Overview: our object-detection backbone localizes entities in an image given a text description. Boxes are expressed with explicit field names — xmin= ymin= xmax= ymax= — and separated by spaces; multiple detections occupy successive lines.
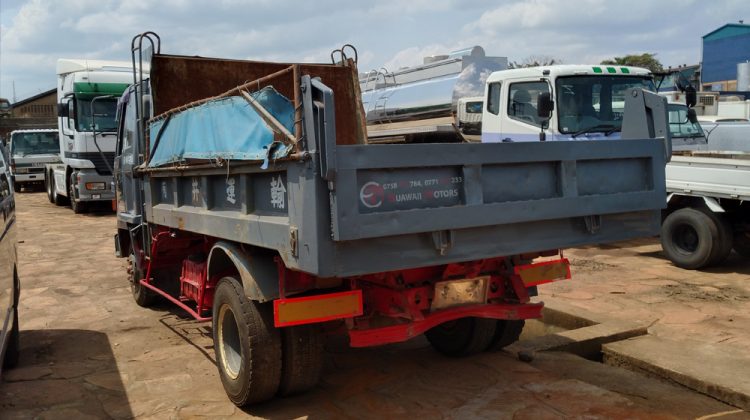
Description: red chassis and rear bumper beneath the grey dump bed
xmin=139 ymin=228 xmax=570 ymax=347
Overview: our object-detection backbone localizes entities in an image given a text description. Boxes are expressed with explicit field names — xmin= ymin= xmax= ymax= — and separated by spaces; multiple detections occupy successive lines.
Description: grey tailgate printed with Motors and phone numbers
xmin=331 ymin=139 xmax=666 ymax=242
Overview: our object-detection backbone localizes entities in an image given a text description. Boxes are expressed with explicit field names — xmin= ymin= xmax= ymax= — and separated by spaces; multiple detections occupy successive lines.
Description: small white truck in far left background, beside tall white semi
xmin=9 ymin=129 xmax=60 ymax=192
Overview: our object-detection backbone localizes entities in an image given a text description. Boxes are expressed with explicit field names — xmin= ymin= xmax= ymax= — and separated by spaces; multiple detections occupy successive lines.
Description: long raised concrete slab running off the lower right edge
xmin=602 ymin=336 xmax=750 ymax=410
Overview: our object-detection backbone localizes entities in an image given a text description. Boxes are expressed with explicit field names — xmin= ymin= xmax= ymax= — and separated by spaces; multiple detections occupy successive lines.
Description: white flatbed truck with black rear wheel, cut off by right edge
xmin=661 ymin=100 xmax=750 ymax=269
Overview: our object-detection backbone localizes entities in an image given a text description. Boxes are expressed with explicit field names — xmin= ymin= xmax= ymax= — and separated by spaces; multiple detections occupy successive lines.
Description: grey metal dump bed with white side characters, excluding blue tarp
xmin=143 ymin=56 xmax=667 ymax=277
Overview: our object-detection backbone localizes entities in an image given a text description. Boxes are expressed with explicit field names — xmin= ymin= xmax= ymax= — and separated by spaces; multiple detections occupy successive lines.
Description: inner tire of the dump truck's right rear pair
xmin=424 ymin=318 xmax=497 ymax=357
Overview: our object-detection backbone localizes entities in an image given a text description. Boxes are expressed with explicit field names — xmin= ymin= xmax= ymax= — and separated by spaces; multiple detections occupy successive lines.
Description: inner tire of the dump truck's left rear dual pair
xmin=278 ymin=325 xmax=323 ymax=396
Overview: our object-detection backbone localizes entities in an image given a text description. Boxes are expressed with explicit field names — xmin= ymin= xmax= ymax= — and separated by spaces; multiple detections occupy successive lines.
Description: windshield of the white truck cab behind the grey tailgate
xmin=555 ymin=76 xmax=655 ymax=134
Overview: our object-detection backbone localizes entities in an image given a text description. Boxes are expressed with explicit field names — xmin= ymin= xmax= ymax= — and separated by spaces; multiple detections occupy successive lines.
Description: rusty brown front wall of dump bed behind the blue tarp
xmin=151 ymin=54 xmax=366 ymax=145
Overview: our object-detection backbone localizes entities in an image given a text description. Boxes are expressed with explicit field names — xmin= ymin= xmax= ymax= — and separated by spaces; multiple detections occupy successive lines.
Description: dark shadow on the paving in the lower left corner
xmin=0 ymin=330 xmax=133 ymax=419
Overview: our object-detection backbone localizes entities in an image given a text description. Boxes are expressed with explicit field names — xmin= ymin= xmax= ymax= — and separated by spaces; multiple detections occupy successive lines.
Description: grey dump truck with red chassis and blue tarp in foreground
xmin=114 ymin=33 xmax=670 ymax=406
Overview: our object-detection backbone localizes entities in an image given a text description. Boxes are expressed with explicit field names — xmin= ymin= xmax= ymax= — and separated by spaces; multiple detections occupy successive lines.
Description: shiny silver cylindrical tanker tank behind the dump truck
xmin=359 ymin=46 xmax=508 ymax=124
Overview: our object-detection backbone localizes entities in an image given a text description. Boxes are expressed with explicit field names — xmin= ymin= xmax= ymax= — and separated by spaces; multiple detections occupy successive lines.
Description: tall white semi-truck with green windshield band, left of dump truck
xmin=44 ymin=59 xmax=133 ymax=213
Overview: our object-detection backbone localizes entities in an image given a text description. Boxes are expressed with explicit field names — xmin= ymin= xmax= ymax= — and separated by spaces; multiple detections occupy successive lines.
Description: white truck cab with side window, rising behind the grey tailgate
xmin=482 ymin=65 xmax=655 ymax=143
